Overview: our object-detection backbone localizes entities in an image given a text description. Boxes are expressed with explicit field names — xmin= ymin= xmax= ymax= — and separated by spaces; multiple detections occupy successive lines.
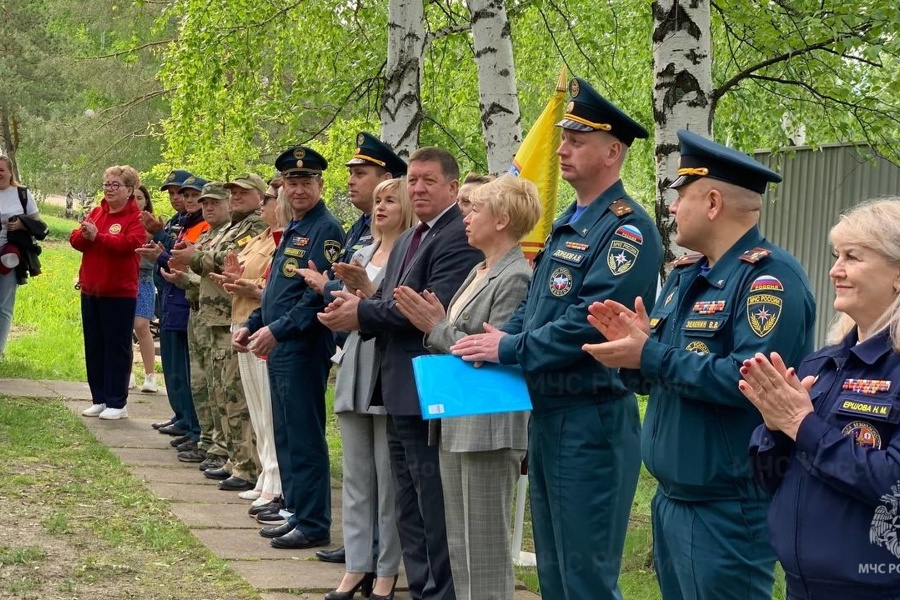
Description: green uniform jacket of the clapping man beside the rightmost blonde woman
xmin=622 ymin=227 xmax=816 ymax=501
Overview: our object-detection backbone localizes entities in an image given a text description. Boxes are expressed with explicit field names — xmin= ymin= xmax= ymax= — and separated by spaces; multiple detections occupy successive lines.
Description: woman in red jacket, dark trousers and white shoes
xmin=69 ymin=165 xmax=146 ymax=419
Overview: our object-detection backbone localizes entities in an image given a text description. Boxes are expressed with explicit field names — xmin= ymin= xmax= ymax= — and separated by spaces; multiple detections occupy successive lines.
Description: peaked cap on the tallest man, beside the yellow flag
xmin=556 ymin=77 xmax=649 ymax=146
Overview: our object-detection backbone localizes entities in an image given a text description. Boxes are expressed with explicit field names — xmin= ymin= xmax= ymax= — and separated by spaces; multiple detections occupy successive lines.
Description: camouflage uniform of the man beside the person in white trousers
xmin=190 ymin=211 xmax=266 ymax=482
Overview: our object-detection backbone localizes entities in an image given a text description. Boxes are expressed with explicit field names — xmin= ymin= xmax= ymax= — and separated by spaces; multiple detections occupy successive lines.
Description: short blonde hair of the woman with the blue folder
xmin=469 ymin=173 xmax=541 ymax=240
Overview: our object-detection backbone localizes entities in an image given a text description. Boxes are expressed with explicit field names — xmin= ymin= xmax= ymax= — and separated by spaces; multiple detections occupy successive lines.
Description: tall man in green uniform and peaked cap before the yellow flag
xmin=452 ymin=79 xmax=662 ymax=600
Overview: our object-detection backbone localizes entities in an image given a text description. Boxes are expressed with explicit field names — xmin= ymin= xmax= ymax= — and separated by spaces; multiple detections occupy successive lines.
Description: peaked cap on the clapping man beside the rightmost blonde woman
xmin=669 ymin=129 xmax=781 ymax=194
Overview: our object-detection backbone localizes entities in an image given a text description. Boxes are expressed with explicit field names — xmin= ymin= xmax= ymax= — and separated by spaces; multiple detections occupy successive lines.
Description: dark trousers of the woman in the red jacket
xmin=81 ymin=294 xmax=137 ymax=408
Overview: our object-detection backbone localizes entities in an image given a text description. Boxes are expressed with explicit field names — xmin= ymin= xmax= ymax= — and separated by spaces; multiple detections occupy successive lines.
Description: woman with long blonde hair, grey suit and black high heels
xmin=325 ymin=179 xmax=414 ymax=600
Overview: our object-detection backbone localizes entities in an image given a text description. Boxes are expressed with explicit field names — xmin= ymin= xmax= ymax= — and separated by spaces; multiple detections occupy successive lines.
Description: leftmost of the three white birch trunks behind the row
xmin=381 ymin=0 xmax=426 ymax=158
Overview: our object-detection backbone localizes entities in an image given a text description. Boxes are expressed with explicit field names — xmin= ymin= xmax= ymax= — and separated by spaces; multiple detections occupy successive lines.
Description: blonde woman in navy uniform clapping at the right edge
xmin=739 ymin=198 xmax=900 ymax=600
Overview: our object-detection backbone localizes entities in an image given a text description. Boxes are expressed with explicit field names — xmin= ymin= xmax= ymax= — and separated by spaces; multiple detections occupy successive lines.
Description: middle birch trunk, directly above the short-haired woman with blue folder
xmin=468 ymin=0 xmax=522 ymax=175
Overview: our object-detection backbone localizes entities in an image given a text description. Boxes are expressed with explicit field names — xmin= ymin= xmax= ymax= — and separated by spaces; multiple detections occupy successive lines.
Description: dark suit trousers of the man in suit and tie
xmin=388 ymin=415 xmax=456 ymax=600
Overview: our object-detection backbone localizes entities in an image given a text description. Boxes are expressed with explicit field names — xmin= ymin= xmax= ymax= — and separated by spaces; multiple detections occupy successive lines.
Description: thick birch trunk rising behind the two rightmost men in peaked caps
xmin=653 ymin=0 xmax=712 ymax=260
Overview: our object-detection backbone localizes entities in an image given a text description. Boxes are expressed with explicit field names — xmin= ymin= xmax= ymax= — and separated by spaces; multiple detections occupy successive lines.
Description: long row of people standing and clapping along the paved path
xmin=0 ymin=74 xmax=884 ymax=600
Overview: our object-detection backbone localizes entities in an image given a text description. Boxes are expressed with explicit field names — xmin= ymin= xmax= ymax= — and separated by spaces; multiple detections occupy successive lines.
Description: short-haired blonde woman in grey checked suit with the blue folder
xmin=394 ymin=175 xmax=541 ymax=600
